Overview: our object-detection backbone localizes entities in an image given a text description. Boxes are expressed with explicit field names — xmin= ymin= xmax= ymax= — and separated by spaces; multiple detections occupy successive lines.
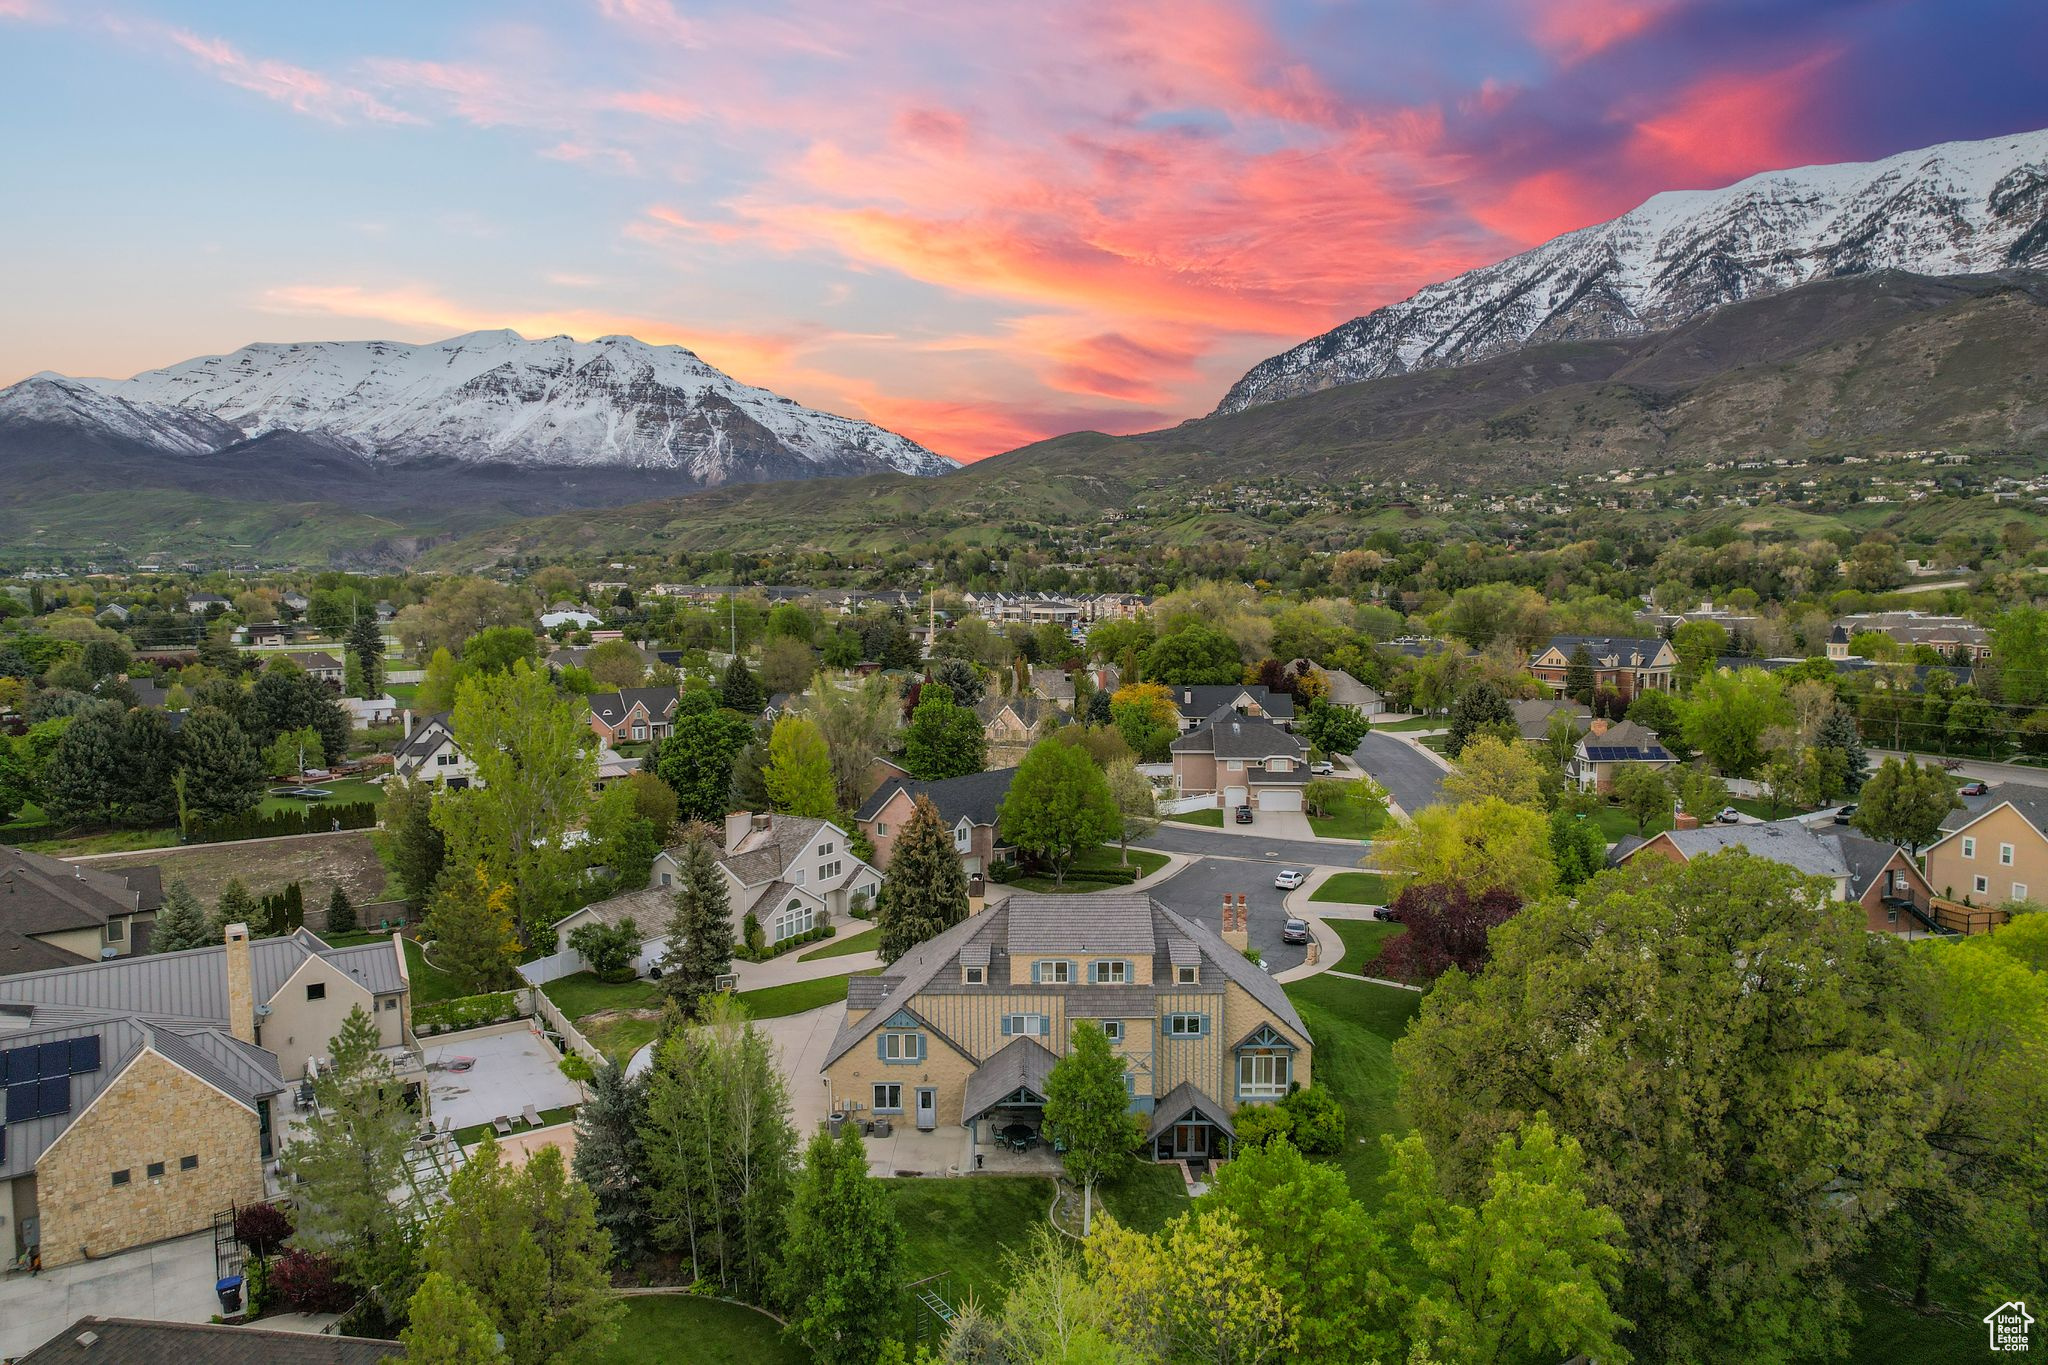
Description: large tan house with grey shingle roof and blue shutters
xmin=823 ymin=892 xmax=1313 ymax=1169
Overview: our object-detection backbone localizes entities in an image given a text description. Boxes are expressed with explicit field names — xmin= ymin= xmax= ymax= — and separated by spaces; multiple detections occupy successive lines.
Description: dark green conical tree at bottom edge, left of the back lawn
xmin=774 ymin=1124 xmax=903 ymax=1365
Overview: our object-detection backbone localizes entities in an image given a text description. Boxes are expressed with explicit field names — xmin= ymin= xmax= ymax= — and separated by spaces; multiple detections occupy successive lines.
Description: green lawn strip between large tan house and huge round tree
xmin=1286 ymin=974 xmax=1421 ymax=1205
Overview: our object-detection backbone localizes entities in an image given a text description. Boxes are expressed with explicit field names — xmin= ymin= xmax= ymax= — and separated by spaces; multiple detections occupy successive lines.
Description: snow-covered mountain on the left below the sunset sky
xmin=0 ymin=332 xmax=954 ymax=485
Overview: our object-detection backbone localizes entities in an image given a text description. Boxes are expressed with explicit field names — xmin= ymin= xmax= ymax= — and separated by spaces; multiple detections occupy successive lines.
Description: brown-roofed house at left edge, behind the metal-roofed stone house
xmin=0 ymin=845 xmax=164 ymax=976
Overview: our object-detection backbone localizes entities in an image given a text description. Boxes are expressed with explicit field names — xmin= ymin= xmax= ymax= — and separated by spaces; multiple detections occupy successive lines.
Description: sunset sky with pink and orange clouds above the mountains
xmin=0 ymin=0 xmax=2048 ymax=458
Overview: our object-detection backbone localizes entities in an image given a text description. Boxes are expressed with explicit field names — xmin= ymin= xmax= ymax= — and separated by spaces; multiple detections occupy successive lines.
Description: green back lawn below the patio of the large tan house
xmin=883 ymin=1175 xmax=1053 ymax=1308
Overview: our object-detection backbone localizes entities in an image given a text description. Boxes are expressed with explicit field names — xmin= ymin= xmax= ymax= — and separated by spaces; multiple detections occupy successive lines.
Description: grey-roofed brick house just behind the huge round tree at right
xmin=1616 ymin=821 xmax=1948 ymax=937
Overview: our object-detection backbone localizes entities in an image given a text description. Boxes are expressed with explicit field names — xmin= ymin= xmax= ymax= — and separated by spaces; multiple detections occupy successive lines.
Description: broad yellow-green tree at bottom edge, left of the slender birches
xmin=422 ymin=1134 xmax=625 ymax=1365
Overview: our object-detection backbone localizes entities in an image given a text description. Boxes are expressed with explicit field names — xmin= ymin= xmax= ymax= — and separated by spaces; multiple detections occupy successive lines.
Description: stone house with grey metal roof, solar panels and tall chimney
xmin=0 ymin=925 xmax=426 ymax=1267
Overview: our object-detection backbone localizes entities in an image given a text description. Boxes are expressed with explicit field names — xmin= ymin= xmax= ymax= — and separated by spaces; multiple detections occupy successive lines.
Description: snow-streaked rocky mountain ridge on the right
xmin=1217 ymin=131 xmax=2048 ymax=413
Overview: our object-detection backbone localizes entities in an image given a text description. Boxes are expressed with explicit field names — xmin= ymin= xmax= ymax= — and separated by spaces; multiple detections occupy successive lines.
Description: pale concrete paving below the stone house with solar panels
xmin=0 ymin=1232 xmax=221 ymax=1361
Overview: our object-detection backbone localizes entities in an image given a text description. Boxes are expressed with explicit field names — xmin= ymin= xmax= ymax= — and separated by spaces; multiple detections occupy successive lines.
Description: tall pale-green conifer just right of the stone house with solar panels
xmin=283 ymin=1005 xmax=418 ymax=1316
